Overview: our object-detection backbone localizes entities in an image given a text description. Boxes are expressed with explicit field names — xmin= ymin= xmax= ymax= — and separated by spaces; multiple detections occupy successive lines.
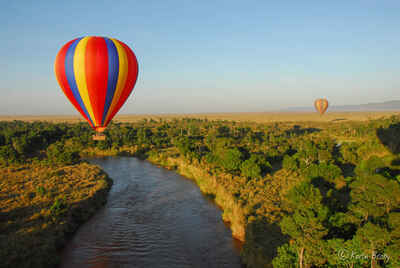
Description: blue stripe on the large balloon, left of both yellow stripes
xmin=64 ymin=37 xmax=94 ymax=126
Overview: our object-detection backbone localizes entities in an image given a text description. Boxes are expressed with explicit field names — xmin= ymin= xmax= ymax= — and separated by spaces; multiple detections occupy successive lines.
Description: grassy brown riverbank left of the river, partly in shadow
xmin=0 ymin=162 xmax=112 ymax=268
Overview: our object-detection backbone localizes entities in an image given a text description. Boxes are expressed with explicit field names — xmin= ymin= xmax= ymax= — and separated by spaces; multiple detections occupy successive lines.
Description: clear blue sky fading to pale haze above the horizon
xmin=0 ymin=0 xmax=400 ymax=114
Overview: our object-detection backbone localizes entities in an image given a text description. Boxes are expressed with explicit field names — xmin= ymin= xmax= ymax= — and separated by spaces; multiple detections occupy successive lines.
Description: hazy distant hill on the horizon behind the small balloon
xmin=285 ymin=100 xmax=400 ymax=112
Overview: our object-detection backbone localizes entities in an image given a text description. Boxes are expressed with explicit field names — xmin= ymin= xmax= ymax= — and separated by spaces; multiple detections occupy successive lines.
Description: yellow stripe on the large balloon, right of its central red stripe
xmin=104 ymin=38 xmax=128 ymax=122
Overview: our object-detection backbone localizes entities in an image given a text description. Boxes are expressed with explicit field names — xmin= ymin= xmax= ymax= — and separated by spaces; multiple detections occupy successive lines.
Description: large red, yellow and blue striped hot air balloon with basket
xmin=54 ymin=36 xmax=138 ymax=139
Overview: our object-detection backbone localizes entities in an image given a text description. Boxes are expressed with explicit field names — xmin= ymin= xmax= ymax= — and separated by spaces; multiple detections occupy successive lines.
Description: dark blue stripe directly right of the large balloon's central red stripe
xmin=101 ymin=37 xmax=119 ymax=125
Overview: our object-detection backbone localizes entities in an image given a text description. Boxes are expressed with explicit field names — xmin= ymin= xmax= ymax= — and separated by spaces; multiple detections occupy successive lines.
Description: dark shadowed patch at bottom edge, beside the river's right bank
xmin=241 ymin=218 xmax=289 ymax=267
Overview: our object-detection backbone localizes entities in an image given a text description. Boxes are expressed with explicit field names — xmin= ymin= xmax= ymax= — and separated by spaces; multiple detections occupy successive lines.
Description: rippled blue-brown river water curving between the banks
xmin=60 ymin=157 xmax=241 ymax=268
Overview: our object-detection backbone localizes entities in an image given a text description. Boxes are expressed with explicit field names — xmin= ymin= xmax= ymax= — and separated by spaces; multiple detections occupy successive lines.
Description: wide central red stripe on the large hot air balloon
xmin=85 ymin=37 xmax=108 ymax=126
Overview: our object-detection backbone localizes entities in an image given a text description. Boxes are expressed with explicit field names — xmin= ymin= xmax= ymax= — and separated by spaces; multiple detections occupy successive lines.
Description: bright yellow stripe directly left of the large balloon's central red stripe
xmin=74 ymin=37 xmax=100 ymax=127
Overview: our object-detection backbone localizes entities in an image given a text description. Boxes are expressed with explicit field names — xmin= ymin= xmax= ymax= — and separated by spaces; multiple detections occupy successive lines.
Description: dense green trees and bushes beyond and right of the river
xmin=0 ymin=116 xmax=400 ymax=267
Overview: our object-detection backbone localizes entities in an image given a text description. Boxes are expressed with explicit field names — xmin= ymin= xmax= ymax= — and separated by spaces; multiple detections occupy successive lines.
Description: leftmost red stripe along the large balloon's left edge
xmin=54 ymin=38 xmax=94 ymax=128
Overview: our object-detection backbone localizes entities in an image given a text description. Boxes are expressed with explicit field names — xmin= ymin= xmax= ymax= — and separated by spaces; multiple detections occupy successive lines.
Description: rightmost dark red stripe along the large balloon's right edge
xmin=104 ymin=40 xmax=138 ymax=126
